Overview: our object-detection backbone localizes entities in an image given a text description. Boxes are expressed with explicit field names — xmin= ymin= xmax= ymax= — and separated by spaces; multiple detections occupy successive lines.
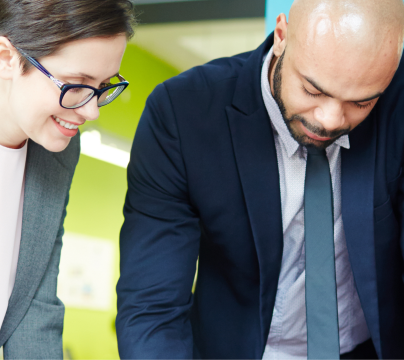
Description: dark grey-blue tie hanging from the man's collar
xmin=304 ymin=147 xmax=339 ymax=359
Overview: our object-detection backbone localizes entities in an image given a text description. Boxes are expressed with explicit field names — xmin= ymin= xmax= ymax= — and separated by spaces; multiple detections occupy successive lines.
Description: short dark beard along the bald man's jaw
xmin=274 ymin=49 xmax=350 ymax=149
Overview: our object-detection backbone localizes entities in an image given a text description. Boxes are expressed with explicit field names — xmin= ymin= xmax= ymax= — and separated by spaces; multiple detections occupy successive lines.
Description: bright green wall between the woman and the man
xmin=63 ymin=44 xmax=178 ymax=359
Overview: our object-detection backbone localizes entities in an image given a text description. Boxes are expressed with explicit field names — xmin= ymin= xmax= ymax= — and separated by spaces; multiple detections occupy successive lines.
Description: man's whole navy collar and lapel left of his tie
xmin=226 ymin=32 xmax=283 ymax=358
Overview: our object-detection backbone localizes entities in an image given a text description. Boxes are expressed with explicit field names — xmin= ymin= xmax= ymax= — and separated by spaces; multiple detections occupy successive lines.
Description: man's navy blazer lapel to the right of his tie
xmin=341 ymin=116 xmax=381 ymax=357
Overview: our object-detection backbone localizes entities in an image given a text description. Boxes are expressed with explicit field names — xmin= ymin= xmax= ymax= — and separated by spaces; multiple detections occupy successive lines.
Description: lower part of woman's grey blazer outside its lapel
xmin=4 ymin=196 xmax=69 ymax=359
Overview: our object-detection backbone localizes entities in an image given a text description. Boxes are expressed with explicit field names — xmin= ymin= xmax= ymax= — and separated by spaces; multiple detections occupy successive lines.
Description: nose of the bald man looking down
xmin=314 ymin=99 xmax=345 ymax=131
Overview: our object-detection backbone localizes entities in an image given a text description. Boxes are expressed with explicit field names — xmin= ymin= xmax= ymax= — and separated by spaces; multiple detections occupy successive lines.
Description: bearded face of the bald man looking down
xmin=272 ymin=37 xmax=397 ymax=148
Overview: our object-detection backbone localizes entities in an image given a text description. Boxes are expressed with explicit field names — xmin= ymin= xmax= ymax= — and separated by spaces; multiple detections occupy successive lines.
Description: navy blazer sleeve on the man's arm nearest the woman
xmin=116 ymin=84 xmax=200 ymax=359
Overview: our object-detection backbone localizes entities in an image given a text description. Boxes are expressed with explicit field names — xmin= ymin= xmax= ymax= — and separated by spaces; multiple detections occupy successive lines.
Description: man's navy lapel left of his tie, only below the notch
xmin=227 ymin=108 xmax=283 ymax=352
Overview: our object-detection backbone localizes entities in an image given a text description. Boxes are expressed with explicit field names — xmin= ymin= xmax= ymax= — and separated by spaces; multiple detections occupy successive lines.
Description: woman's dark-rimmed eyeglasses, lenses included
xmin=15 ymin=47 xmax=129 ymax=109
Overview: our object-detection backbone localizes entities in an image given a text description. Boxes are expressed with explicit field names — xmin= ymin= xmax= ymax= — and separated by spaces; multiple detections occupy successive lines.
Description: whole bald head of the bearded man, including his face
xmin=269 ymin=0 xmax=404 ymax=148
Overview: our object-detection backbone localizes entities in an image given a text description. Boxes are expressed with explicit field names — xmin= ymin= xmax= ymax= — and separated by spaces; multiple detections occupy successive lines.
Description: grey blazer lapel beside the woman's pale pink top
xmin=0 ymin=141 xmax=71 ymax=346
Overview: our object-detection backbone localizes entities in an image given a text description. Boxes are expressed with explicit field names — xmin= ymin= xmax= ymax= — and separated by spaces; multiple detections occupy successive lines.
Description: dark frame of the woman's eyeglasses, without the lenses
xmin=14 ymin=46 xmax=129 ymax=109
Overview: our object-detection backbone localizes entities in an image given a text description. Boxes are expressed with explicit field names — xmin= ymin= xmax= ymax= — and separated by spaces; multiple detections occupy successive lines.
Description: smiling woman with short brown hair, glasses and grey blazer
xmin=0 ymin=0 xmax=134 ymax=359
